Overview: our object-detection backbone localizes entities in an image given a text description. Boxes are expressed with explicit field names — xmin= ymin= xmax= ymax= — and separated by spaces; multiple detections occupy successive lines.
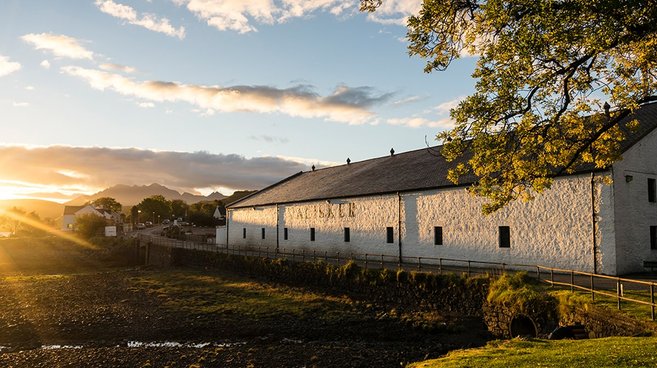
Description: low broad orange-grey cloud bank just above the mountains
xmin=0 ymin=146 xmax=309 ymax=193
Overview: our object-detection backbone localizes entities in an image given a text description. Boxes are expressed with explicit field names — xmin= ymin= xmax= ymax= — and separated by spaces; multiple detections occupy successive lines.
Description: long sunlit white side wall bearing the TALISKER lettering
xmin=228 ymin=174 xmax=616 ymax=274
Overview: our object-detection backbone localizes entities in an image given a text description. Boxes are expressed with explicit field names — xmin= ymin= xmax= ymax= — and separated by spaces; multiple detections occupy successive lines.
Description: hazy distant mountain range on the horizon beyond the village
xmin=66 ymin=183 xmax=226 ymax=206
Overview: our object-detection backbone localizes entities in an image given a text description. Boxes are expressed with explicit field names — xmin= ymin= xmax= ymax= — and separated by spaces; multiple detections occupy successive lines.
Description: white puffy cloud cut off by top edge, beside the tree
xmin=174 ymin=0 xmax=421 ymax=33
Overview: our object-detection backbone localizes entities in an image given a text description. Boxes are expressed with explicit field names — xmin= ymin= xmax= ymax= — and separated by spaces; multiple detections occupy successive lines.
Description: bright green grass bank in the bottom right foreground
xmin=410 ymin=337 xmax=657 ymax=368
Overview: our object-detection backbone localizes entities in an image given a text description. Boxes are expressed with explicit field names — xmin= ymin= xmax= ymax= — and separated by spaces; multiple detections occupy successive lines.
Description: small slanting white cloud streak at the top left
xmin=96 ymin=0 xmax=185 ymax=40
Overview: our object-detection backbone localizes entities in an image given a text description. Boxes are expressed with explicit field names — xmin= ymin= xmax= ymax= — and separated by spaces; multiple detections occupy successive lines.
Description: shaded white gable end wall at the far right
xmin=613 ymin=126 xmax=657 ymax=273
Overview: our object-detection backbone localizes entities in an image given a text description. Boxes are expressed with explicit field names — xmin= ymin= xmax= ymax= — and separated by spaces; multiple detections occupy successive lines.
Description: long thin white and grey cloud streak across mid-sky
xmin=61 ymin=66 xmax=390 ymax=124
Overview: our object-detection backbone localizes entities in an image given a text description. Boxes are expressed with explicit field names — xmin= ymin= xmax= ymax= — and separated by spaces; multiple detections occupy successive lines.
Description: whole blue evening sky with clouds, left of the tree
xmin=0 ymin=0 xmax=476 ymax=202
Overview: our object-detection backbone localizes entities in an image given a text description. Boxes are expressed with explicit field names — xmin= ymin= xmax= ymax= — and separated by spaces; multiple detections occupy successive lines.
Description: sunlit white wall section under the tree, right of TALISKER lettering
xmin=404 ymin=175 xmax=611 ymax=271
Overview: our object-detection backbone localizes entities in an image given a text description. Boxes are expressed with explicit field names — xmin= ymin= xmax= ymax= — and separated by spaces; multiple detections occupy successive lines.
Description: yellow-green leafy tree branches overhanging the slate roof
xmin=361 ymin=0 xmax=657 ymax=213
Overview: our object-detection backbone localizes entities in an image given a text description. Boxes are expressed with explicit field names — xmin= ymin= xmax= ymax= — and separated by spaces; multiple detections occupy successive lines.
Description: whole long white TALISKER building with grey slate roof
xmin=222 ymin=104 xmax=657 ymax=275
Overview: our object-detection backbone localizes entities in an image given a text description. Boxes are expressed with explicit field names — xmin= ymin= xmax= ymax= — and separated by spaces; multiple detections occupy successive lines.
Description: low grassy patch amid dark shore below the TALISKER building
xmin=131 ymin=270 xmax=356 ymax=320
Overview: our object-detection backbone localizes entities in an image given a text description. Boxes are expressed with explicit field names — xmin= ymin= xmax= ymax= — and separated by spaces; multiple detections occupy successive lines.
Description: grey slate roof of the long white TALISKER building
xmin=228 ymin=103 xmax=657 ymax=208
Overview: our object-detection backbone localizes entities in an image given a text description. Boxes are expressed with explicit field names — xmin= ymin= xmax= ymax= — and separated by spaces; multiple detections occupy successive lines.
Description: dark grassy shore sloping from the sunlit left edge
xmin=0 ymin=239 xmax=487 ymax=368
